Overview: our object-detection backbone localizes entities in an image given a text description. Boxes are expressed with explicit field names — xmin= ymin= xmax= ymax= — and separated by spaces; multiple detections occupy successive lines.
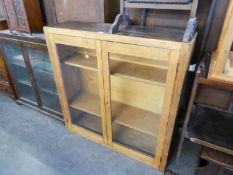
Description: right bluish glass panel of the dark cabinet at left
xmin=26 ymin=48 xmax=61 ymax=113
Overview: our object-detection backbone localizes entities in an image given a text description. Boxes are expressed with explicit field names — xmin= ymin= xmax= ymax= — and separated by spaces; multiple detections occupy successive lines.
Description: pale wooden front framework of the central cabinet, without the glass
xmin=44 ymin=22 xmax=196 ymax=171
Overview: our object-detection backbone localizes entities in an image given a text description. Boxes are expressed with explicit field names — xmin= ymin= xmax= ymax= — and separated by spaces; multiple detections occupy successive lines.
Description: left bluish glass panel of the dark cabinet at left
xmin=3 ymin=43 xmax=36 ymax=103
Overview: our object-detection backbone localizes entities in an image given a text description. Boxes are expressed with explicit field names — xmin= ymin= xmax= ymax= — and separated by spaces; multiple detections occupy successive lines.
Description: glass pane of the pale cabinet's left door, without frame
xmin=57 ymin=44 xmax=103 ymax=135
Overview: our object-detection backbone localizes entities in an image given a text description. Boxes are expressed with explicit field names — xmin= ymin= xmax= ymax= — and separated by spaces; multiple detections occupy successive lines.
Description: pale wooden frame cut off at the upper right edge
xmin=208 ymin=1 xmax=233 ymax=84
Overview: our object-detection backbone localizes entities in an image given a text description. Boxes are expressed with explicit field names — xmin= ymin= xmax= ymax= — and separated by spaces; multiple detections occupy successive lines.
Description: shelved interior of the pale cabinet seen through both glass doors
xmin=57 ymin=44 xmax=169 ymax=157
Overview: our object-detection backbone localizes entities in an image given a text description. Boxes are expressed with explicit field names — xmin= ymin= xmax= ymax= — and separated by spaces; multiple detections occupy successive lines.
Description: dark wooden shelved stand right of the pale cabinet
xmin=177 ymin=55 xmax=233 ymax=158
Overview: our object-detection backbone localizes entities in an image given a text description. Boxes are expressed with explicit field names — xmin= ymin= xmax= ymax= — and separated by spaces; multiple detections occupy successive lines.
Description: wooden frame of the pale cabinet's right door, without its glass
xmin=102 ymin=41 xmax=180 ymax=168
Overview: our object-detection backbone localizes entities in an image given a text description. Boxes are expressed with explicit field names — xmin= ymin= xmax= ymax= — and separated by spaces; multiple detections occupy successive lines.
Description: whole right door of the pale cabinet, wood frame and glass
xmin=102 ymin=42 xmax=178 ymax=164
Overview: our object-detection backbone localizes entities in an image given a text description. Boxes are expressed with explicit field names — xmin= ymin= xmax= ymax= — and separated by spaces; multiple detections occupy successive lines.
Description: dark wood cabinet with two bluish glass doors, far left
xmin=0 ymin=32 xmax=62 ymax=120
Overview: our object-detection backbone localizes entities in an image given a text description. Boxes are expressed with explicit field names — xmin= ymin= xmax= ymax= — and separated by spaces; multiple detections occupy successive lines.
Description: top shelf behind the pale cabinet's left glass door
xmin=64 ymin=53 xmax=98 ymax=71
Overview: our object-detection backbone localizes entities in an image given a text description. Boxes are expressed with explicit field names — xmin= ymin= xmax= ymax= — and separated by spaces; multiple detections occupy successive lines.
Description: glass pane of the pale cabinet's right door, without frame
xmin=109 ymin=53 xmax=168 ymax=157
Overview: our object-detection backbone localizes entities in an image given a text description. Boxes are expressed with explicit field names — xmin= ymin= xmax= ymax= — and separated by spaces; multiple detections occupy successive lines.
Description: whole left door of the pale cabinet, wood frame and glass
xmin=52 ymin=35 xmax=106 ymax=142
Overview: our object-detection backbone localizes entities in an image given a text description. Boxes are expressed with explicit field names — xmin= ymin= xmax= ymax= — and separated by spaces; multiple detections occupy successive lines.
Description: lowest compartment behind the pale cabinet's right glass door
xmin=113 ymin=124 xmax=156 ymax=156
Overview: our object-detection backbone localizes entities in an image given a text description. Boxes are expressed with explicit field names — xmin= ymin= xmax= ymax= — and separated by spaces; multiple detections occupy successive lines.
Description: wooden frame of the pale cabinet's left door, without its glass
xmin=45 ymin=30 xmax=107 ymax=144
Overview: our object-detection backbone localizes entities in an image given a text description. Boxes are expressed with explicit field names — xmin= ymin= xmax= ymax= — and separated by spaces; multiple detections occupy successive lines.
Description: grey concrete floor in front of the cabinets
xmin=0 ymin=93 xmax=199 ymax=175
